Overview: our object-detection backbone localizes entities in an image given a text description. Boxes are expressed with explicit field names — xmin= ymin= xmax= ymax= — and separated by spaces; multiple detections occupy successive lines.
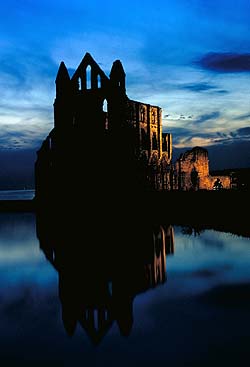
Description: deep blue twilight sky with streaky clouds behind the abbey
xmin=0 ymin=0 xmax=250 ymax=168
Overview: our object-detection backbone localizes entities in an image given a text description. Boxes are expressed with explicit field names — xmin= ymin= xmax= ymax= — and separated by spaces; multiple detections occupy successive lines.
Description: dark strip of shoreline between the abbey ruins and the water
xmin=0 ymin=191 xmax=250 ymax=237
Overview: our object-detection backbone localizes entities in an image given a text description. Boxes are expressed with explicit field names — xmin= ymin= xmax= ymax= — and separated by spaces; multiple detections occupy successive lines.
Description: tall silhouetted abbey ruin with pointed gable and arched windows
xmin=35 ymin=53 xmax=172 ymax=203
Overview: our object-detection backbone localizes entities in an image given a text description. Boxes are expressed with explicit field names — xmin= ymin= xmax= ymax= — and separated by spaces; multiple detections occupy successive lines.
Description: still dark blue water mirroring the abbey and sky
xmin=0 ymin=213 xmax=250 ymax=367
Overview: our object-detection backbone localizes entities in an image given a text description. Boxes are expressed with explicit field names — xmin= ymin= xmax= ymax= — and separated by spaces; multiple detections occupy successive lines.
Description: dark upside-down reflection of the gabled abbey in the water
xmin=37 ymin=218 xmax=174 ymax=344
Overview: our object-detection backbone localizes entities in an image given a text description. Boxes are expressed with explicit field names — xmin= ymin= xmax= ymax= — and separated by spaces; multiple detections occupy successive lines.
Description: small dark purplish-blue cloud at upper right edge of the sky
xmin=198 ymin=52 xmax=250 ymax=73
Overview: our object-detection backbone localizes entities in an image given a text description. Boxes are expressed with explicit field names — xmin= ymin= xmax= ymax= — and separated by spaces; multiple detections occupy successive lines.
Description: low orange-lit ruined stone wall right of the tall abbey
xmin=175 ymin=147 xmax=231 ymax=191
